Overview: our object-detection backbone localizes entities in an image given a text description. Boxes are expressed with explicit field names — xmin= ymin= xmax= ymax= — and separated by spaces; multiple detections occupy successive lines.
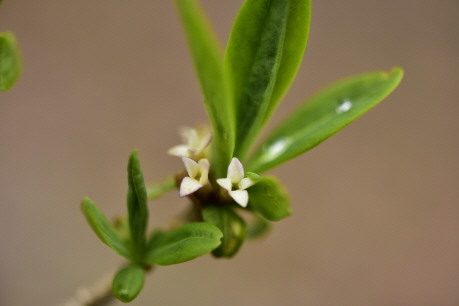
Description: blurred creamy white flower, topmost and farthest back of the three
xmin=167 ymin=127 xmax=212 ymax=158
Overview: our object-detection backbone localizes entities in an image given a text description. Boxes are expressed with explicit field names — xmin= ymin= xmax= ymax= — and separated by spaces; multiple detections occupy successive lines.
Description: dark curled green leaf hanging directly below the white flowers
xmin=202 ymin=206 xmax=247 ymax=257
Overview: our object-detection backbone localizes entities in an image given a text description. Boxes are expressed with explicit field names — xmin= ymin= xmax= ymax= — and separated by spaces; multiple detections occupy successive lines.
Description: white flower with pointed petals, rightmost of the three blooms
xmin=217 ymin=157 xmax=256 ymax=207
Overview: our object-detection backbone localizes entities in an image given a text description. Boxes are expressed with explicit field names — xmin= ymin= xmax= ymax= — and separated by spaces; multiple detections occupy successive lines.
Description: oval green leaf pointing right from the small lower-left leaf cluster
xmin=147 ymin=222 xmax=223 ymax=266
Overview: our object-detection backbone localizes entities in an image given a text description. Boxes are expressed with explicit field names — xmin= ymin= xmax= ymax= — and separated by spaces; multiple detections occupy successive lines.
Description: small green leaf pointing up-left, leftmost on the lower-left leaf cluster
xmin=81 ymin=198 xmax=130 ymax=259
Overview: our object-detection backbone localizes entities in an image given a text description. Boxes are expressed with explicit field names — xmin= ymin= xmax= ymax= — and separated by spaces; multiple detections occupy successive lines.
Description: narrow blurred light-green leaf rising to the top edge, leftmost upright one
xmin=176 ymin=0 xmax=235 ymax=177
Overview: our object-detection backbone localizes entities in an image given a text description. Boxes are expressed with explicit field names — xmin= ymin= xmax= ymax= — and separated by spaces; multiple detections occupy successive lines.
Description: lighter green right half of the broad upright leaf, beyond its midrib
xmin=262 ymin=0 xmax=311 ymax=125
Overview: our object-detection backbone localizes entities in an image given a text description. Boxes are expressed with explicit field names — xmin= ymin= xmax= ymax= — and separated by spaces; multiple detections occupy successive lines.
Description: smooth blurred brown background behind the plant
xmin=0 ymin=0 xmax=459 ymax=306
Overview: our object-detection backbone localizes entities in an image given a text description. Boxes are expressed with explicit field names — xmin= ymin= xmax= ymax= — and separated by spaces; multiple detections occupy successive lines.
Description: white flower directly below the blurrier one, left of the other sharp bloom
xmin=180 ymin=157 xmax=210 ymax=197
